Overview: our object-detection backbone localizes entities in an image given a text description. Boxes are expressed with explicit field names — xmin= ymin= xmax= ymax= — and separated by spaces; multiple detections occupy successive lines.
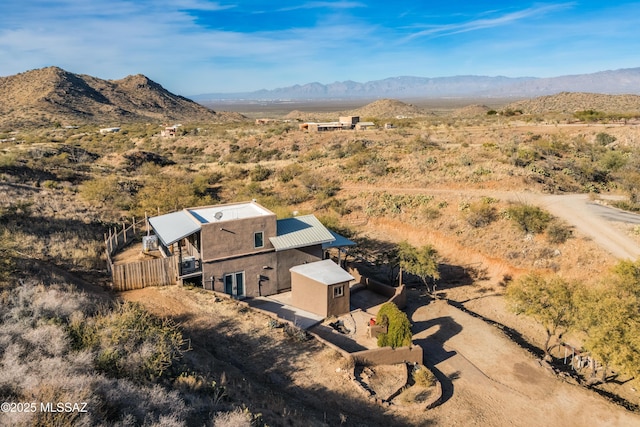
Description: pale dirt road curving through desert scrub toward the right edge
xmin=343 ymin=185 xmax=640 ymax=260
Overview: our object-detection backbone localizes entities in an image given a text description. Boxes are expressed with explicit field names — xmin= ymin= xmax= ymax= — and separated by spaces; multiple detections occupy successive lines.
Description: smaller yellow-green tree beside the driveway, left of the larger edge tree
xmin=506 ymin=273 xmax=576 ymax=359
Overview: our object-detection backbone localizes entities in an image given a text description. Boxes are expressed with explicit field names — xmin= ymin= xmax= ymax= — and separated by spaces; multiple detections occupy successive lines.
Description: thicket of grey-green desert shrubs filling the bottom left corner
xmin=0 ymin=281 xmax=200 ymax=426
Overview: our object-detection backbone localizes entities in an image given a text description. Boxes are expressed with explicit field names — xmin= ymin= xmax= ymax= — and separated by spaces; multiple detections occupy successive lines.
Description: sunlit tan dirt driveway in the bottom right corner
xmin=412 ymin=301 xmax=640 ymax=426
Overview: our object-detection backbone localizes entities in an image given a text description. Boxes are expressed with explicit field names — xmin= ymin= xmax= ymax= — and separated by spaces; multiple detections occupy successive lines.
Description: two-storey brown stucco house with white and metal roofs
xmin=149 ymin=202 xmax=353 ymax=298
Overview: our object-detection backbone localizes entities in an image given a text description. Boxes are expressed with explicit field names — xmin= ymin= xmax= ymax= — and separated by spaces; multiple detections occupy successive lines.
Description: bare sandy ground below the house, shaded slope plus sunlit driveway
xmin=121 ymin=286 xmax=640 ymax=426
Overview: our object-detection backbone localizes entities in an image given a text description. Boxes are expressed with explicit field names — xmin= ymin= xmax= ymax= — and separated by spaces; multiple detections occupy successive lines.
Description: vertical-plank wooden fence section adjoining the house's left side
xmin=111 ymin=256 xmax=178 ymax=291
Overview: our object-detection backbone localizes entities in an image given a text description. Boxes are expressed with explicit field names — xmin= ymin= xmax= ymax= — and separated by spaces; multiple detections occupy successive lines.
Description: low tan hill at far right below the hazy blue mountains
xmin=505 ymin=92 xmax=640 ymax=114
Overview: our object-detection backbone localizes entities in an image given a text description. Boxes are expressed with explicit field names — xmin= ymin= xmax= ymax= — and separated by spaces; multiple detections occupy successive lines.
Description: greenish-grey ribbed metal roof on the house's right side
xmin=269 ymin=215 xmax=335 ymax=251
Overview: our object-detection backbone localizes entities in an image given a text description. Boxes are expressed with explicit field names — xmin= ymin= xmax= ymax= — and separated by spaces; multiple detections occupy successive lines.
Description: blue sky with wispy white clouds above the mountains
xmin=0 ymin=0 xmax=640 ymax=96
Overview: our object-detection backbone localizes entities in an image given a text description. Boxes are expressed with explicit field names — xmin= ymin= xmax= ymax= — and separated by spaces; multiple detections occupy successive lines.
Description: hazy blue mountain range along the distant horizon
xmin=191 ymin=67 xmax=640 ymax=104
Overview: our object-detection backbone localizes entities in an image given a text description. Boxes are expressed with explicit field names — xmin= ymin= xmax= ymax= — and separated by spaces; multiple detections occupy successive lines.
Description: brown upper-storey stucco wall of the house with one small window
xmin=201 ymin=214 xmax=277 ymax=261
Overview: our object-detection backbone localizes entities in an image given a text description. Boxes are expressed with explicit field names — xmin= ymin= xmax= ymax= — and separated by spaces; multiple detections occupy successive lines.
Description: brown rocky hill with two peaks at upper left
xmin=0 ymin=67 xmax=242 ymax=128
